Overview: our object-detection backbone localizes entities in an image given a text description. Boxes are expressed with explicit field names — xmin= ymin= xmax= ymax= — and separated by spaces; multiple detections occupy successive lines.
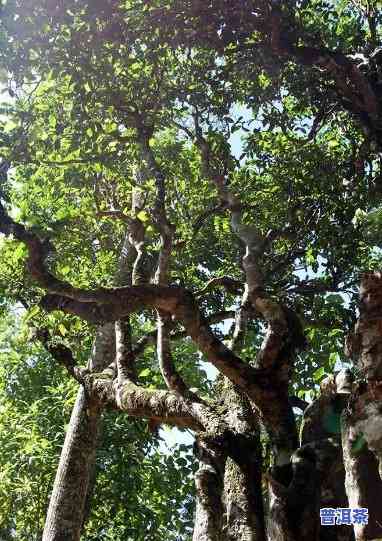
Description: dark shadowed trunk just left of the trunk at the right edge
xmin=267 ymin=371 xmax=354 ymax=541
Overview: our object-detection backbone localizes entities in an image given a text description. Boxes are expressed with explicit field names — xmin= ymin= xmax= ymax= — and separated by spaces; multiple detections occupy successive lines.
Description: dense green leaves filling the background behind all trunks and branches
xmin=0 ymin=0 xmax=382 ymax=540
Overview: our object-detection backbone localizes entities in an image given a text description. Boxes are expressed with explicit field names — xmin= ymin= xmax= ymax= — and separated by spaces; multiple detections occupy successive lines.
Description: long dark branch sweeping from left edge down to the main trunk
xmin=0 ymin=198 xmax=293 ymax=448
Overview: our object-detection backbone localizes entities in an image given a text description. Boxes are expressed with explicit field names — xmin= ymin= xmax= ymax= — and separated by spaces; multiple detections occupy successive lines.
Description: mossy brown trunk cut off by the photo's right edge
xmin=342 ymin=272 xmax=382 ymax=541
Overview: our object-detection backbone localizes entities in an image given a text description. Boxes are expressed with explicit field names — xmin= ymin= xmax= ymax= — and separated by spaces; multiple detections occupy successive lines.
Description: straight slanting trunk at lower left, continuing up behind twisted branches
xmin=42 ymin=232 xmax=135 ymax=541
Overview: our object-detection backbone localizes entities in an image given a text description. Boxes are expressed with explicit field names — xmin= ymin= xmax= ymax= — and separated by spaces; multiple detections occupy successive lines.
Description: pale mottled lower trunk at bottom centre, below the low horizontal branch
xmin=193 ymin=378 xmax=265 ymax=541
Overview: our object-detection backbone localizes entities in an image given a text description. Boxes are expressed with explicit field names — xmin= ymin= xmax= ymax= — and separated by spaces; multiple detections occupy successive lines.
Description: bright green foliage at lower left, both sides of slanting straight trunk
xmin=0 ymin=310 xmax=197 ymax=541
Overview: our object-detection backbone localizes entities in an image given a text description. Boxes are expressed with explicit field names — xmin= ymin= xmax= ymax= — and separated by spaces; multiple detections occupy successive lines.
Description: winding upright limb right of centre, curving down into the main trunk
xmin=194 ymin=121 xmax=305 ymax=463
